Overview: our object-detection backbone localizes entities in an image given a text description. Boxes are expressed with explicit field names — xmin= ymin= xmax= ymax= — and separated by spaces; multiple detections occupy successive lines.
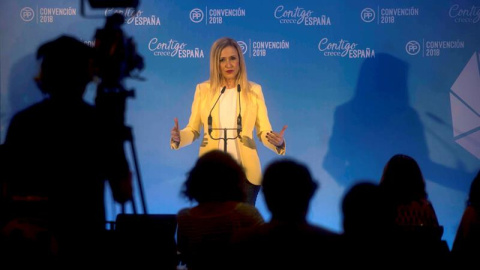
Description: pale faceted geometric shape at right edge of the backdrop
xmin=450 ymin=52 xmax=480 ymax=159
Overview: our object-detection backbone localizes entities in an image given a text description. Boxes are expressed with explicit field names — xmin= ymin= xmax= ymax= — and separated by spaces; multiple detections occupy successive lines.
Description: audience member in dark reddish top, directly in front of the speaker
xmin=177 ymin=150 xmax=264 ymax=270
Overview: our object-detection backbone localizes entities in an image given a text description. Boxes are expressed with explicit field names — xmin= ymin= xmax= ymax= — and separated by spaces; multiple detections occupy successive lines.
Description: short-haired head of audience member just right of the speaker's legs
xmin=262 ymin=159 xmax=317 ymax=220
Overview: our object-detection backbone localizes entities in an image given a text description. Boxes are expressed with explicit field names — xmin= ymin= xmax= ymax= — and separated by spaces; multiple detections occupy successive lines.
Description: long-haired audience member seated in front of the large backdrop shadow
xmin=379 ymin=154 xmax=450 ymax=267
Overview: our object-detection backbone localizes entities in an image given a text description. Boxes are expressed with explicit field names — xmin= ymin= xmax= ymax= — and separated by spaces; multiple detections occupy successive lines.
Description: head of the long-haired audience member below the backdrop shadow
xmin=380 ymin=154 xmax=427 ymax=203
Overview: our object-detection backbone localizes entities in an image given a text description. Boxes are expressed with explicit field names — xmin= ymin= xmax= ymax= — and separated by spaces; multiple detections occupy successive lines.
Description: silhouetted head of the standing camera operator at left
xmin=35 ymin=35 xmax=94 ymax=100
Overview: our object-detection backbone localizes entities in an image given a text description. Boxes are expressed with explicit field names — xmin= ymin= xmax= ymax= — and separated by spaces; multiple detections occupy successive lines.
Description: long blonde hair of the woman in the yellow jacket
xmin=210 ymin=37 xmax=250 ymax=97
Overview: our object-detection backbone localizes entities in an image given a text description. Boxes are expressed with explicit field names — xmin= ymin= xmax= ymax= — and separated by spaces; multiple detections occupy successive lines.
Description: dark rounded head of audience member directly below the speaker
xmin=182 ymin=150 xmax=247 ymax=203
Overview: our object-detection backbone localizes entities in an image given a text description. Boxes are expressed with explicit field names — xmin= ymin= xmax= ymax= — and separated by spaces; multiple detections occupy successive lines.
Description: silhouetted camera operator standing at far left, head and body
xmin=1 ymin=36 xmax=132 ymax=266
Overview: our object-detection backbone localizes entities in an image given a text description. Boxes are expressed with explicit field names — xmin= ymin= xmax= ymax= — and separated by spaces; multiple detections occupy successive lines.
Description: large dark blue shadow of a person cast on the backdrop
xmin=323 ymin=53 xmax=473 ymax=191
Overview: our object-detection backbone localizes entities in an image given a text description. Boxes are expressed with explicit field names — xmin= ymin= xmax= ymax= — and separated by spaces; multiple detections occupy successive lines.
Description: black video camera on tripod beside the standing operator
xmin=81 ymin=0 xmax=144 ymax=125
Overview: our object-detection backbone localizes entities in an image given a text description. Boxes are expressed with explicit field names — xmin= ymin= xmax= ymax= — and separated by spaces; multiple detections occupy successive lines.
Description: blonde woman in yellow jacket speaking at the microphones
xmin=170 ymin=37 xmax=287 ymax=205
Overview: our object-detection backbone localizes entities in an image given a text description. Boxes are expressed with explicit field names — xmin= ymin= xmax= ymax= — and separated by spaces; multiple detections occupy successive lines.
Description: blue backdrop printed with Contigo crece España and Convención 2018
xmin=0 ymin=0 xmax=480 ymax=249
